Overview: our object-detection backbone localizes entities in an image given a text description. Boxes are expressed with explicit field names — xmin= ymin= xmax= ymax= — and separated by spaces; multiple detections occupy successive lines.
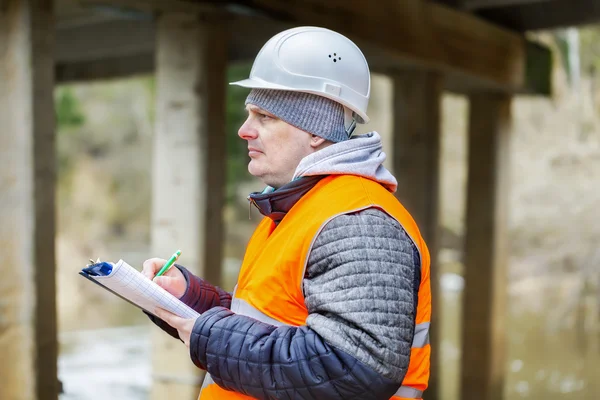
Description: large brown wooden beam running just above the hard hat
xmin=68 ymin=0 xmax=550 ymax=94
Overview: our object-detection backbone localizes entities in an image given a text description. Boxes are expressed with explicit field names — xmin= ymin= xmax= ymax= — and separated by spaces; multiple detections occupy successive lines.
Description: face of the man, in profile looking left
xmin=238 ymin=104 xmax=314 ymax=188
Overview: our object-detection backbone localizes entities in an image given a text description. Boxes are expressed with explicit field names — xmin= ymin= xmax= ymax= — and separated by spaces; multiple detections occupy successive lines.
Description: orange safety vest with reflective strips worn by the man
xmin=199 ymin=175 xmax=431 ymax=400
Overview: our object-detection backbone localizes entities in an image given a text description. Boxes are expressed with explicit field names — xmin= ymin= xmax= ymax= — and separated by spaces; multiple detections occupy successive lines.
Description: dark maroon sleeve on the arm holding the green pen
xmin=145 ymin=264 xmax=231 ymax=339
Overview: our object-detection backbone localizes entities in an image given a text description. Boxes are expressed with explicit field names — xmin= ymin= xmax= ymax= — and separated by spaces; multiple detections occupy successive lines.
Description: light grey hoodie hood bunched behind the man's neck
xmin=292 ymin=132 xmax=398 ymax=193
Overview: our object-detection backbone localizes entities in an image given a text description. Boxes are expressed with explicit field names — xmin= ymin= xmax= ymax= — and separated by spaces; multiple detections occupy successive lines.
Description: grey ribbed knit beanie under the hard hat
xmin=246 ymin=89 xmax=348 ymax=143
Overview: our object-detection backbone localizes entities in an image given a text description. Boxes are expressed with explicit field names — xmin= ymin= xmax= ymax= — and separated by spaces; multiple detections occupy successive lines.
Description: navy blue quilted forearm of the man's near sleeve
xmin=190 ymin=307 xmax=400 ymax=400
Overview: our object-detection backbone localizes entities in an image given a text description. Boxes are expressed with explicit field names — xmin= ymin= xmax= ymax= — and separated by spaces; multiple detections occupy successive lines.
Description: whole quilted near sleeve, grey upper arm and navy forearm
xmin=190 ymin=210 xmax=420 ymax=400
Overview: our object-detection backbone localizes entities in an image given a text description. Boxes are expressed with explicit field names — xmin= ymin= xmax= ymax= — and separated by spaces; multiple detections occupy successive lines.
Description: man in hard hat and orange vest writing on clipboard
xmin=143 ymin=27 xmax=431 ymax=400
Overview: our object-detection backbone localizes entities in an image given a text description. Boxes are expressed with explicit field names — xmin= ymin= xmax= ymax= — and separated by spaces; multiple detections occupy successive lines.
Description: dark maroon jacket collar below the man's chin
xmin=248 ymin=175 xmax=324 ymax=224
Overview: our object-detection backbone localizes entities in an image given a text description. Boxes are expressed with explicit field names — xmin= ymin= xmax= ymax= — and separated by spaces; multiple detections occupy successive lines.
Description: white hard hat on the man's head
xmin=231 ymin=26 xmax=371 ymax=124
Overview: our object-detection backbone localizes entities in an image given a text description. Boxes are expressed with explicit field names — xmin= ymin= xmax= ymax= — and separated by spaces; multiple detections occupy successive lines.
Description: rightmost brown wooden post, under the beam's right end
xmin=460 ymin=94 xmax=511 ymax=400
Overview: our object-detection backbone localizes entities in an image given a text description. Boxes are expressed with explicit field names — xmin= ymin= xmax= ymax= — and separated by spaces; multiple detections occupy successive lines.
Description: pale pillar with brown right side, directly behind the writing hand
xmin=152 ymin=13 xmax=227 ymax=399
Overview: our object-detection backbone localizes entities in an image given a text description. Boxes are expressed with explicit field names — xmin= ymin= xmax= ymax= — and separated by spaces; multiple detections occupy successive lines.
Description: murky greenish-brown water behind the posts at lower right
xmin=440 ymin=274 xmax=600 ymax=400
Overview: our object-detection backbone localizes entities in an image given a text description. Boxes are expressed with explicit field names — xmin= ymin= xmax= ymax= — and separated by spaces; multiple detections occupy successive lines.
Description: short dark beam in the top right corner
xmin=478 ymin=0 xmax=600 ymax=32
